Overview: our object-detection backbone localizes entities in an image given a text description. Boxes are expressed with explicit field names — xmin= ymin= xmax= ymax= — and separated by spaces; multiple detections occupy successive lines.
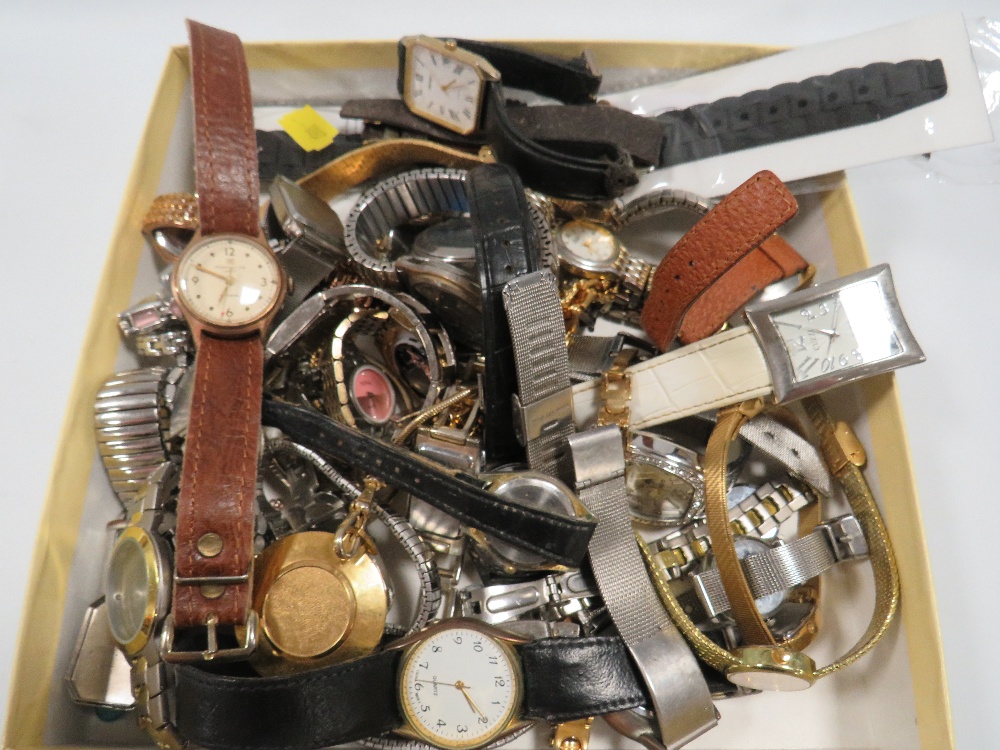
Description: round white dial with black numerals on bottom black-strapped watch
xmin=400 ymin=626 xmax=520 ymax=750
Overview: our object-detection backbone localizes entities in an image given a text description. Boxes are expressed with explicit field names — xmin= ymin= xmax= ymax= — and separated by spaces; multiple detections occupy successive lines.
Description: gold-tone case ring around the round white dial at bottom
xmin=387 ymin=617 xmax=534 ymax=750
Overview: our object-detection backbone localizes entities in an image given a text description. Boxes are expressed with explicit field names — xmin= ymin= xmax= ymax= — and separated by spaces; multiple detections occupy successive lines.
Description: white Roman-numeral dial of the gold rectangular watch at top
xmin=406 ymin=44 xmax=484 ymax=133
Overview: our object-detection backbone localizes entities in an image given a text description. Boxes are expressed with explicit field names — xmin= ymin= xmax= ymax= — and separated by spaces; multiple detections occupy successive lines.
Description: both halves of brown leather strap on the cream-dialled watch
xmin=172 ymin=21 xmax=264 ymax=628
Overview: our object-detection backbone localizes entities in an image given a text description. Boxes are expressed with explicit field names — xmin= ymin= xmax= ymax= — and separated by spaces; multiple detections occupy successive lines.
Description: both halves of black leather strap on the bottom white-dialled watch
xmin=176 ymin=636 xmax=649 ymax=750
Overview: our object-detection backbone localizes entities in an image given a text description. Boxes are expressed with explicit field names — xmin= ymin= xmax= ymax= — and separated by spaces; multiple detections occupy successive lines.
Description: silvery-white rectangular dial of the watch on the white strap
xmin=771 ymin=281 xmax=902 ymax=383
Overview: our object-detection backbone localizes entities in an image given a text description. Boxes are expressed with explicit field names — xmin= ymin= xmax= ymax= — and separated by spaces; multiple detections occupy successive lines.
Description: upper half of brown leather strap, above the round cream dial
xmin=188 ymin=21 xmax=260 ymax=237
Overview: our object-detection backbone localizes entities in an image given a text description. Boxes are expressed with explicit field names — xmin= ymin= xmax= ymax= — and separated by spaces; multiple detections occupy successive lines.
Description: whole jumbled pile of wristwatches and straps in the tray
xmin=69 ymin=22 xmax=934 ymax=750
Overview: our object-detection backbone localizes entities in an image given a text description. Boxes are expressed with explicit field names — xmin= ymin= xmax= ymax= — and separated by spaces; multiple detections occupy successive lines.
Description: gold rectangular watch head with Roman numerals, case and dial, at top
xmin=400 ymin=36 xmax=500 ymax=135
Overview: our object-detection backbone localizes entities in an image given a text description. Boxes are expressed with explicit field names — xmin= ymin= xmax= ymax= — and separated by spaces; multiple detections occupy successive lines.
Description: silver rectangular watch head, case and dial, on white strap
xmin=746 ymin=264 xmax=924 ymax=402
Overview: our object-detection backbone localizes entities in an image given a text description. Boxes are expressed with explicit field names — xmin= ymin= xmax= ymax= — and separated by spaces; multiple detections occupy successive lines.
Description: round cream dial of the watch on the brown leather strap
xmin=174 ymin=235 xmax=282 ymax=328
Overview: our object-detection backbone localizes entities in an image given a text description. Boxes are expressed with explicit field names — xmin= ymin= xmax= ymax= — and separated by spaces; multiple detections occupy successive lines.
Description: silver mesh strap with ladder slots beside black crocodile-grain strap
xmin=503 ymin=271 xmax=575 ymax=481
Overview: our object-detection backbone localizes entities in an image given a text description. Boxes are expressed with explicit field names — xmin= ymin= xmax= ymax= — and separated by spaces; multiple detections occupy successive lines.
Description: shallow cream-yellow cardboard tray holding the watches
xmin=4 ymin=42 xmax=954 ymax=750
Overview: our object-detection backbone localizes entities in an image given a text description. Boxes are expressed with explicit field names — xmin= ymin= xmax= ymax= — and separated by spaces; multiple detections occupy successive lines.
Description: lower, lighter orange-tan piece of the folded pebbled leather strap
xmin=677 ymin=234 xmax=809 ymax=344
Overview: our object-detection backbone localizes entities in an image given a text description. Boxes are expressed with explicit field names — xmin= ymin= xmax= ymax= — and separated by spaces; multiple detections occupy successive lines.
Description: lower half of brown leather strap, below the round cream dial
xmin=173 ymin=333 xmax=264 ymax=628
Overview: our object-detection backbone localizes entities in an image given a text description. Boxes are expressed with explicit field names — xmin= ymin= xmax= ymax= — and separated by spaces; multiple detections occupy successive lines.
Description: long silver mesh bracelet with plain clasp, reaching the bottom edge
xmin=569 ymin=425 xmax=717 ymax=749
